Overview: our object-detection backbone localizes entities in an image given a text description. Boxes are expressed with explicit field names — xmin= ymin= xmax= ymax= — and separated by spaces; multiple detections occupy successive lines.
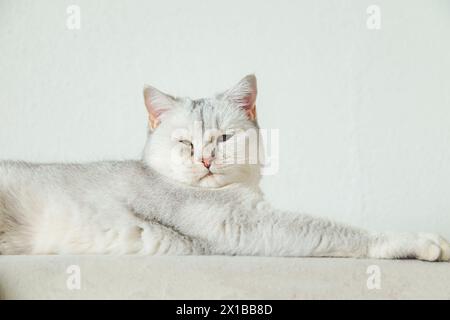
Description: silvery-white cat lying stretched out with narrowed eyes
xmin=0 ymin=75 xmax=450 ymax=261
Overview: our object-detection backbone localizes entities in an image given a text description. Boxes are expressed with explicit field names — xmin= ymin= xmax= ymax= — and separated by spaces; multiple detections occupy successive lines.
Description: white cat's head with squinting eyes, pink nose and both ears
xmin=143 ymin=75 xmax=261 ymax=188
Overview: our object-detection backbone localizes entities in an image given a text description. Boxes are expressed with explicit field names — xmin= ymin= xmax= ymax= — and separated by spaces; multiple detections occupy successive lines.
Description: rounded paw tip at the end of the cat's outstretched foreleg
xmin=417 ymin=233 xmax=450 ymax=261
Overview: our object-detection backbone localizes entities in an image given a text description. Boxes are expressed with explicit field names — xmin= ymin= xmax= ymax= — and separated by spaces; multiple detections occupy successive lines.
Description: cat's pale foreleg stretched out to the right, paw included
xmin=191 ymin=205 xmax=450 ymax=261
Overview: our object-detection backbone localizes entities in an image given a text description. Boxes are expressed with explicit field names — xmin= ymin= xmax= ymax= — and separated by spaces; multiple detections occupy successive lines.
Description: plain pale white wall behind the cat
xmin=0 ymin=0 xmax=450 ymax=237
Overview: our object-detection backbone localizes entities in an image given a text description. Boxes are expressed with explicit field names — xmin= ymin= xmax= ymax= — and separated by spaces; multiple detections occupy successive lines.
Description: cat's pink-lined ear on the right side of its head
xmin=224 ymin=74 xmax=258 ymax=120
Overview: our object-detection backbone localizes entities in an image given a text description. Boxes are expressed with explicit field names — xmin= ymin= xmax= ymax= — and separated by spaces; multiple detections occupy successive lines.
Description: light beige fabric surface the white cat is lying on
xmin=0 ymin=256 xmax=450 ymax=299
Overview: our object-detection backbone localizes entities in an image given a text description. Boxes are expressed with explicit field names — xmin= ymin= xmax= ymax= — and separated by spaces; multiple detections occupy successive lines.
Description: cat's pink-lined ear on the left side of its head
xmin=144 ymin=85 xmax=175 ymax=130
